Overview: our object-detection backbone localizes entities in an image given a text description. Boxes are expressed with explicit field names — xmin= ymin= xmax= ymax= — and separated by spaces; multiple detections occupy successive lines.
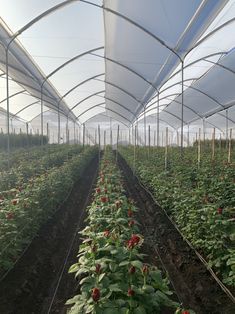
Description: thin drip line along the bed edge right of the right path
xmin=132 ymin=170 xmax=235 ymax=303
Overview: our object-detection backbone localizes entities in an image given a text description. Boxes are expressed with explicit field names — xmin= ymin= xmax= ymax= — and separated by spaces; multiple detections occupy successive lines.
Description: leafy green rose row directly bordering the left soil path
xmin=0 ymin=148 xmax=96 ymax=274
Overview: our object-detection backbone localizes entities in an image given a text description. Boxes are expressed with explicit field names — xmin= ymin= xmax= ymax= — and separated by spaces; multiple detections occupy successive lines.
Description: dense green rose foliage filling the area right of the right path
xmin=121 ymin=148 xmax=235 ymax=287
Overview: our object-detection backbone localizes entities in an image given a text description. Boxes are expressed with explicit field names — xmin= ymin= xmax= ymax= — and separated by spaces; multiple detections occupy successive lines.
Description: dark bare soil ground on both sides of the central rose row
xmin=0 ymin=151 xmax=235 ymax=314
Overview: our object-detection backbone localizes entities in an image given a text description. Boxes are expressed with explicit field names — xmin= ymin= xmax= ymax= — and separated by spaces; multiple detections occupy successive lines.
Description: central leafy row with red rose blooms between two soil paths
xmin=67 ymin=151 xmax=189 ymax=314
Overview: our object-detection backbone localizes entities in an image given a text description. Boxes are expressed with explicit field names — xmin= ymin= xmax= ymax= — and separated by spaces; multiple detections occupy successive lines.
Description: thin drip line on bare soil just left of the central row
xmin=47 ymin=159 xmax=99 ymax=314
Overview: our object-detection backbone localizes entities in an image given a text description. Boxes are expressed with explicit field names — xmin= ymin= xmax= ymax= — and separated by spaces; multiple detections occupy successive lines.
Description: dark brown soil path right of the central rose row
xmin=118 ymin=155 xmax=235 ymax=314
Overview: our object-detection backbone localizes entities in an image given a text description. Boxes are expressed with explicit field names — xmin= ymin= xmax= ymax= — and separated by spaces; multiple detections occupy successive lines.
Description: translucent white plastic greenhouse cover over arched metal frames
xmin=0 ymin=0 xmax=235 ymax=136
